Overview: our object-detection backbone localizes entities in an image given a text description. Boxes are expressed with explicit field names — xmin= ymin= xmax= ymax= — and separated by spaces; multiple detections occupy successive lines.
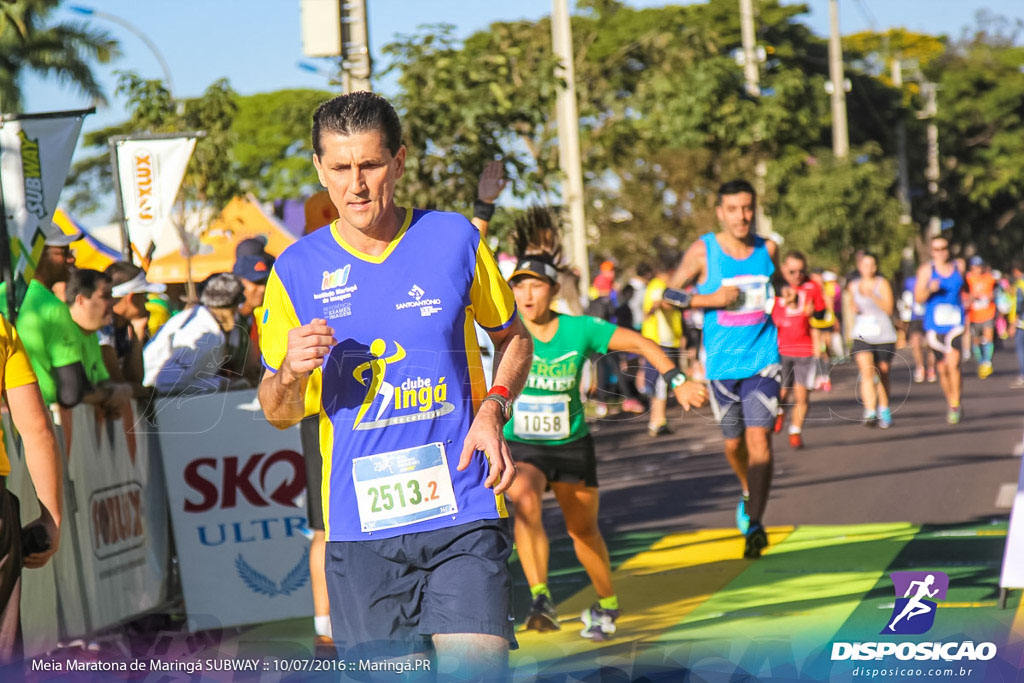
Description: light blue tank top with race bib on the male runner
xmin=697 ymin=232 xmax=779 ymax=380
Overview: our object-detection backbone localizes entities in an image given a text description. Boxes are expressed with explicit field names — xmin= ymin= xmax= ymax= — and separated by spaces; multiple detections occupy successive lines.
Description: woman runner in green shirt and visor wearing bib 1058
xmin=505 ymin=208 xmax=707 ymax=640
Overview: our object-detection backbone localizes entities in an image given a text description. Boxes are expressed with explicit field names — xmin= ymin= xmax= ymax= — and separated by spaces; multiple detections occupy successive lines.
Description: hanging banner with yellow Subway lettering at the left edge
xmin=0 ymin=110 xmax=93 ymax=298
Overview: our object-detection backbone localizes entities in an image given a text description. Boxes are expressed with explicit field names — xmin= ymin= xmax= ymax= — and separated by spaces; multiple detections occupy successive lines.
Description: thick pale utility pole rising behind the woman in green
xmin=551 ymin=0 xmax=590 ymax=292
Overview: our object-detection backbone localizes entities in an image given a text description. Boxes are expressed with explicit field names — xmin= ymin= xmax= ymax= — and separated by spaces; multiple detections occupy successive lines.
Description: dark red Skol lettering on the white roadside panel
xmin=184 ymin=451 xmax=306 ymax=512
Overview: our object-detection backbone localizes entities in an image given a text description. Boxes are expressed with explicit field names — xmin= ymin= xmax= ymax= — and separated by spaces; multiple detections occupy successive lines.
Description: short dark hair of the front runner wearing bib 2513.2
xmin=312 ymin=90 xmax=401 ymax=157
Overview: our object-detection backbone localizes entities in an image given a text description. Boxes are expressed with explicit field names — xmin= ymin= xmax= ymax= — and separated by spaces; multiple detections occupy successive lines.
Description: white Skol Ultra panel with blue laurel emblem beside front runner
xmin=157 ymin=389 xmax=313 ymax=630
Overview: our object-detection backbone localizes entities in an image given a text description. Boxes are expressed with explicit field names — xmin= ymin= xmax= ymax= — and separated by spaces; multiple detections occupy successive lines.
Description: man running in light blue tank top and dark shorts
xmin=667 ymin=180 xmax=781 ymax=558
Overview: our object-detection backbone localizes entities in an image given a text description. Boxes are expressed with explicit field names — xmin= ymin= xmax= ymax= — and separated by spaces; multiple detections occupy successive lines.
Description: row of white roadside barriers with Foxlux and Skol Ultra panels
xmin=3 ymin=389 xmax=312 ymax=655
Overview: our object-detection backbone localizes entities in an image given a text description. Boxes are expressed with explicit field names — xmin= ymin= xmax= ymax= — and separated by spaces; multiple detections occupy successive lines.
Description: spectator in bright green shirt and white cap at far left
xmin=0 ymin=228 xmax=89 ymax=408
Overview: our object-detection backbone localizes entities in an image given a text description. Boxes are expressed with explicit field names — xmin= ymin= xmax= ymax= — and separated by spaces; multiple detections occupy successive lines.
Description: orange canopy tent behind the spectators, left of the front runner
xmin=145 ymin=197 xmax=295 ymax=283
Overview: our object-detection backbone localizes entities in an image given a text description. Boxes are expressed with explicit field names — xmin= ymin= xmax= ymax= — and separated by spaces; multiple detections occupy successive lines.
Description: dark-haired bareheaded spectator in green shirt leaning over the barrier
xmin=65 ymin=268 xmax=132 ymax=418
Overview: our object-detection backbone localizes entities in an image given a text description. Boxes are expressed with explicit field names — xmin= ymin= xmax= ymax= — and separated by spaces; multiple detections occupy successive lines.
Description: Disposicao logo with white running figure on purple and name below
xmin=831 ymin=571 xmax=996 ymax=661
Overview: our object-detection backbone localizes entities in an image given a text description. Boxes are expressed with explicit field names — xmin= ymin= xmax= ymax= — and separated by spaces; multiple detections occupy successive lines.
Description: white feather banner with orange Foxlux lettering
xmin=117 ymin=137 xmax=196 ymax=254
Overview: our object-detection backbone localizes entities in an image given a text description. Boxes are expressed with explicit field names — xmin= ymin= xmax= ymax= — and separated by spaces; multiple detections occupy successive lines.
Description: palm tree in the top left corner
xmin=0 ymin=0 xmax=120 ymax=113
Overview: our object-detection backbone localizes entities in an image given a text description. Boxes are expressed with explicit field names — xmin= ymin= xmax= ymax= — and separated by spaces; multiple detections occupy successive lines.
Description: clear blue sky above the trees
xmin=16 ymin=0 xmax=1024 ymax=224
